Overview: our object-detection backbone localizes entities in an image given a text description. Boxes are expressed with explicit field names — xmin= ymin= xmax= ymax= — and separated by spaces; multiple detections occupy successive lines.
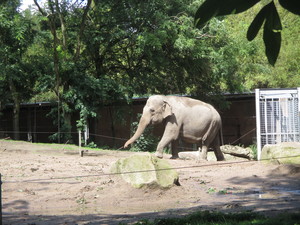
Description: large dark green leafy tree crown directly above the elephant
xmin=84 ymin=0 xmax=239 ymax=100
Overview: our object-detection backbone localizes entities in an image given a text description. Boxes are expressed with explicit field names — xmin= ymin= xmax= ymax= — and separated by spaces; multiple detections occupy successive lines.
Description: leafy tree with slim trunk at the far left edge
xmin=0 ymin=0 xmax=35 ymax=139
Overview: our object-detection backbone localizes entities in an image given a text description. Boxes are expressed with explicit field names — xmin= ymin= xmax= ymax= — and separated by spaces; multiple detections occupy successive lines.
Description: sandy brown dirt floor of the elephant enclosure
xmin=0 ymin=140 xmax=300 ymax=225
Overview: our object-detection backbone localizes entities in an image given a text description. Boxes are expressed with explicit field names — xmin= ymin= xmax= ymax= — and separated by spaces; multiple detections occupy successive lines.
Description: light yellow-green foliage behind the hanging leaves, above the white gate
xmin=221 ymin=4 xmax=300 ymax=91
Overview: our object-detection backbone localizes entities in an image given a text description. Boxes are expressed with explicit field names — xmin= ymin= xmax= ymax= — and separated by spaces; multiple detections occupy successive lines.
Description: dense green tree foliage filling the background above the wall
xmin=0 ymin=0 xmax=300 ymax=141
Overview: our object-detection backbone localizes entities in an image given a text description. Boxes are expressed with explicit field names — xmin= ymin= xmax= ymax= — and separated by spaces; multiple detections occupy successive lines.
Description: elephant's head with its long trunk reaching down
xmin=124 ymin=95 xmax=173 ymax=148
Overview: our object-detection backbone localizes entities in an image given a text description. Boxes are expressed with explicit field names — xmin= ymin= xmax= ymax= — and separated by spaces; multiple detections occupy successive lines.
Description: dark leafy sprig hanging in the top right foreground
xmin=195 ymin=0 xmax=300 ymax=66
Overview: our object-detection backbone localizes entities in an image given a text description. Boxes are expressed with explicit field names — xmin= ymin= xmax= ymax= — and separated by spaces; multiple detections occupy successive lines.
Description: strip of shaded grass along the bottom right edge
xmin=127 ymin=211 xmax=300 ymax=225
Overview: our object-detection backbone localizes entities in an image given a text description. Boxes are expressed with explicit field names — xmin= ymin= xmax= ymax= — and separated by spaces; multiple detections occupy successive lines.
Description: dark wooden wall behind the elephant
xmin=0 ymin=95 xmax=256 ymax=149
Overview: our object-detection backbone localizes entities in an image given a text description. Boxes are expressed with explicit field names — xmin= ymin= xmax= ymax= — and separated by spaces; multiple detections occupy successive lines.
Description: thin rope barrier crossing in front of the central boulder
xmin=3 ymin=154 xmax=300 ymax=183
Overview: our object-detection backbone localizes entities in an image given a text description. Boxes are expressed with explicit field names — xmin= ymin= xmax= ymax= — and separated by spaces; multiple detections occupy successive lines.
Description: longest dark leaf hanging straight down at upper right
xmin=263 ymin=2 xmax=282 ymax=66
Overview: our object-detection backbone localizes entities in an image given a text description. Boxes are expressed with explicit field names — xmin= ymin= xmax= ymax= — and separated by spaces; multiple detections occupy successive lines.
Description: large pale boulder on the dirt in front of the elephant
xmin=111 ymin=153 xmax=179 ymax=188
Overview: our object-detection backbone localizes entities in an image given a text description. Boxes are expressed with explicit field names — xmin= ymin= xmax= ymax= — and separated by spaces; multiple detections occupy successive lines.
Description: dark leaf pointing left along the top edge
xmin=195 ymin=0 xmax=260 ymax=28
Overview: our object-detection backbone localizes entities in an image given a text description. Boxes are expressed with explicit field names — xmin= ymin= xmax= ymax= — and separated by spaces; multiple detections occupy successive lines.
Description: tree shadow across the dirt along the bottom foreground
xmin=3 ymin=195 xmax=300 ymax=225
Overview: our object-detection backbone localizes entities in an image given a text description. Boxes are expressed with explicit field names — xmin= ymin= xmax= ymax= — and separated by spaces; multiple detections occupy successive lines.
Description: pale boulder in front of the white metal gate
xmin=261 ymin=142 xmax=300 ymax=164
